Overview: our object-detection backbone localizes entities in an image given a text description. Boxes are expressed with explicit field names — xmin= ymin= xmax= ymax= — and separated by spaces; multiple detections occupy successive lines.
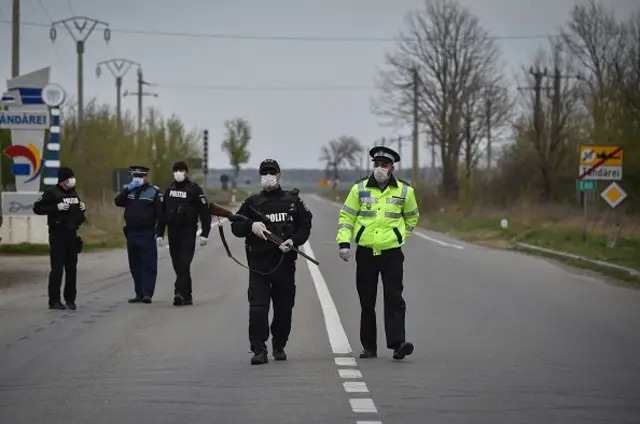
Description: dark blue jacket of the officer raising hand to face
xmin=114 ymin=183 xmax=162 ymax=231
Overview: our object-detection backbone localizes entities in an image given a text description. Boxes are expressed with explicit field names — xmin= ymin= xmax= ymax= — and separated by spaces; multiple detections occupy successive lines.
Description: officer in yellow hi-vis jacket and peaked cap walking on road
xmin=336 ymin=147 xmax=419 ymax=359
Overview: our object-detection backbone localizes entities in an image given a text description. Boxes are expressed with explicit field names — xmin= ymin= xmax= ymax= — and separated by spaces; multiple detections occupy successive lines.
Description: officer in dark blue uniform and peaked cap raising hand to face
xmin=114 ymin=166 xmax=163 ymax=303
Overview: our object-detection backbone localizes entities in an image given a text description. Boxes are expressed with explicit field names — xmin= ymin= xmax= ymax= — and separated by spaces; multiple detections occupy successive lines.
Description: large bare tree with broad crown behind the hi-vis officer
xmin=372 ymin=0 xmax=500 ymax=199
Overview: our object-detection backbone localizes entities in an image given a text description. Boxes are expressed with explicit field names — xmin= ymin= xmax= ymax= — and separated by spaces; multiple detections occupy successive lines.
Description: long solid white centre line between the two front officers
xmin=301 ymin=241 xmax=352 ymax=353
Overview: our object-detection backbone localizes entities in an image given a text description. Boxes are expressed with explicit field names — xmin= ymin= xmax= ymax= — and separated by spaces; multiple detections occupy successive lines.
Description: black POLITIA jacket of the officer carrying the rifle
xmin=231 ymin=187 xmax=313 ymax=258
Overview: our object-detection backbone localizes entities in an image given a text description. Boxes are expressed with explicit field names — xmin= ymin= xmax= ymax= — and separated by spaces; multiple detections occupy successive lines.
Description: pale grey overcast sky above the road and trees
xmin=0 ymin=0 xmax=640 ymax=168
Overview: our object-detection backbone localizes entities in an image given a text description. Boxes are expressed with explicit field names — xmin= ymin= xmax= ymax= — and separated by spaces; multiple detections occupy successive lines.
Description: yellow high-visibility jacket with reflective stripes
xmin=336 ymin=175 xmax=420 ymax=255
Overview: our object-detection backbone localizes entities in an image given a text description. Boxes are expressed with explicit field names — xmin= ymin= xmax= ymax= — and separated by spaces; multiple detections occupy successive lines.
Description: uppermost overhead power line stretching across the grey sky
xmin=0 ymin=19 xmax=553 ymax=43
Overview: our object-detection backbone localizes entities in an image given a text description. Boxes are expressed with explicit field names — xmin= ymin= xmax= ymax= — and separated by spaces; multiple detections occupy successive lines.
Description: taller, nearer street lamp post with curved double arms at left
xmin=49 ymin=16 xmax=111 ymax=132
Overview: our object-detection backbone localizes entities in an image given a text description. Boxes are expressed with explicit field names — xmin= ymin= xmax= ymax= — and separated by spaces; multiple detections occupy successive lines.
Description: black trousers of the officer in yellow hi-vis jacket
xmin=356 ymin=247 xmax=407 ymax=350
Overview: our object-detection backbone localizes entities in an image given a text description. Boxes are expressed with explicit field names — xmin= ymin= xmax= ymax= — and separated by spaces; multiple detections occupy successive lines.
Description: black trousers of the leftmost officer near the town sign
xmin=48 ymin=229 xmax=78 ymax=305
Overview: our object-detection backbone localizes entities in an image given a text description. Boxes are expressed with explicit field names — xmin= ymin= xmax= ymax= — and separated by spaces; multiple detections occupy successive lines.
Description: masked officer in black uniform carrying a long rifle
xmin=231 ymin=159 xmax=313 ymax=365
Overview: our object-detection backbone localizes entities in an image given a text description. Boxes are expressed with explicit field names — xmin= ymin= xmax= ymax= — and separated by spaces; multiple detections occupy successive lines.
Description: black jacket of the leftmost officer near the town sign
xmin=33 ymin=185 xmax=86 ymax=231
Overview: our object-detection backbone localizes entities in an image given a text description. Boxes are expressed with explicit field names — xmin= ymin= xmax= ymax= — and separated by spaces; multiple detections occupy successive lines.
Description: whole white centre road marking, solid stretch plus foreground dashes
xmin=301 ymin=241 xmax=382 ymax=424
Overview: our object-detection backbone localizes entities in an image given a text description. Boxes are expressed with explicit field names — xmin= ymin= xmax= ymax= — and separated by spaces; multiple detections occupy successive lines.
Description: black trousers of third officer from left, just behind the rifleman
xmin=168 ymin=227 xmax=197 ymax=300
